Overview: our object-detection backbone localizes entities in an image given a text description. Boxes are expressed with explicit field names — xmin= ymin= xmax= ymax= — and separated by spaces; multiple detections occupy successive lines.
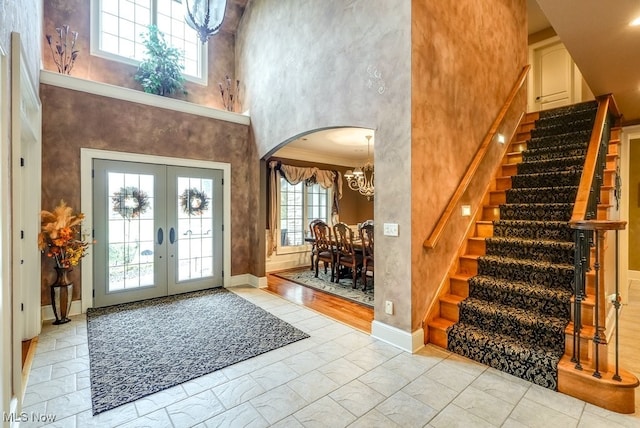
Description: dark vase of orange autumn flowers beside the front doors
xmin=38 ymin=201 xmax=89 ymax=324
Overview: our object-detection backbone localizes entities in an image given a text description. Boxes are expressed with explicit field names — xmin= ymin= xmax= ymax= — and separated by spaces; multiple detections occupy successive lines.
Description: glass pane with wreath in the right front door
xmin=177 ymin=176 xmax=214 ymax=282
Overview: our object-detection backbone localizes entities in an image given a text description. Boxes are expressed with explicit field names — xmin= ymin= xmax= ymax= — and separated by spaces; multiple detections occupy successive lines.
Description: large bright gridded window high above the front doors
xmin=91 ymin=0 xmax=207 ymax=85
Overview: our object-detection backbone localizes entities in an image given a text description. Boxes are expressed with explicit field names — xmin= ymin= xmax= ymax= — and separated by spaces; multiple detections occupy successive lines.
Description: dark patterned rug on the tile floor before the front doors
xmin=87 ymin=288 xmax=309 ymax=415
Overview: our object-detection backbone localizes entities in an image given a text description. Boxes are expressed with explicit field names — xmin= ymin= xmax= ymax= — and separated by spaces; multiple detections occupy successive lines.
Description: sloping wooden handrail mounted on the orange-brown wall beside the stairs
xmin=423 ymin=64 xmax=531 ymax=248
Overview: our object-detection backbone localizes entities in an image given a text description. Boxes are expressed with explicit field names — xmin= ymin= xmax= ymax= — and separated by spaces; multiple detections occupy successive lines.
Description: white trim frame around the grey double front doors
xmin=80 ymin=148 xmax=231 ymax=312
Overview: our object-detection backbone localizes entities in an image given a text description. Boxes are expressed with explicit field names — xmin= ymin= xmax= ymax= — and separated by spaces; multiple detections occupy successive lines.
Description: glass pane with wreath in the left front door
xmin=107 ymin=172 xmax=154 ymax=293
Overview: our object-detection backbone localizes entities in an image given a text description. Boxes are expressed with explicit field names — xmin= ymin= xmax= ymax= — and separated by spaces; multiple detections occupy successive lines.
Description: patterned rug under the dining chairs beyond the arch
xmin=273 ymin=267 xmax=373 ymax=308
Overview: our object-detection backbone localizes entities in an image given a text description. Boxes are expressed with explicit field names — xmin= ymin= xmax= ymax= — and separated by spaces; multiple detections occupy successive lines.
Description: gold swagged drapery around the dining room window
xmin=267 ymin=161 xmax=342 ymax=256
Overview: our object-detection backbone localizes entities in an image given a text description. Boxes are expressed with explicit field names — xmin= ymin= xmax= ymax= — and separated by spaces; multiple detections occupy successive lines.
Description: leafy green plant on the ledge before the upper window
xmin=135 ymin=25 xmax=187 ymax=95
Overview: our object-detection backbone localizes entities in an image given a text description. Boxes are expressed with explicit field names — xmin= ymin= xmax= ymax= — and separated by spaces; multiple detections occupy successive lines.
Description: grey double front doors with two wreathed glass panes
xmin=93 ymin=159 xmax=223 ymax=307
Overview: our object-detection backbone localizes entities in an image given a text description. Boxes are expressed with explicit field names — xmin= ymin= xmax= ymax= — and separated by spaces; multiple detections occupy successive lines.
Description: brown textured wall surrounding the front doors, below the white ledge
xmin=40 ymin=84 xmax=255 ymax=305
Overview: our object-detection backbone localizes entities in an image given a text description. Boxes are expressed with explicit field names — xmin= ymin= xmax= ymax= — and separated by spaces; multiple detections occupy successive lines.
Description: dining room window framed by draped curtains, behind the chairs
xmin=280 ymin=177 xmax=330 ymax=247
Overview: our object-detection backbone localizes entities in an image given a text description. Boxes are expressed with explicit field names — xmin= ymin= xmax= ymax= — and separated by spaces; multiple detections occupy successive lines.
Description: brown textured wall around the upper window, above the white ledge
xmin=42 ymin=0 xmax=242 ymax=112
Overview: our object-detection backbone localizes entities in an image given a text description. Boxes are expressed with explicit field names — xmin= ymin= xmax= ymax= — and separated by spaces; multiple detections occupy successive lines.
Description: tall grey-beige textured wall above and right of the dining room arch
xmin=236 ymin=0 xmax=411 ymax=330
